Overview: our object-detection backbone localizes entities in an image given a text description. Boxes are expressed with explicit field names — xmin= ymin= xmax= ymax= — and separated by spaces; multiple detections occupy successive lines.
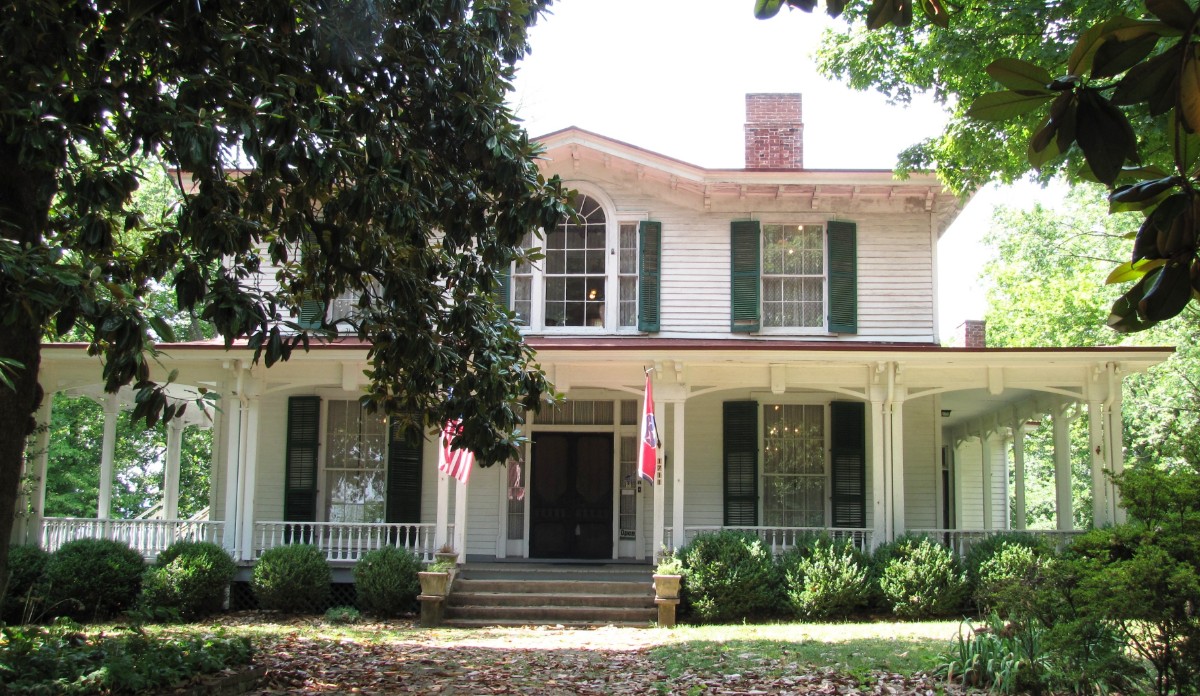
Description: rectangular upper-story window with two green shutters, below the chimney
xmin=730 ymin=220 xmax=858 ymax=334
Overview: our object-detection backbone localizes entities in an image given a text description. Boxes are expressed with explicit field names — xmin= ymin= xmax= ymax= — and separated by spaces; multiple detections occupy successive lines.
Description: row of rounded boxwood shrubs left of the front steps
xmin=0 ymin=539 xmax=421 ymax=624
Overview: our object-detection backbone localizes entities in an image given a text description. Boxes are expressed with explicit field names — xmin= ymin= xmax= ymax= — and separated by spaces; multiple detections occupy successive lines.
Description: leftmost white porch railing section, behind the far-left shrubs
xmin=41 ymin=517 xmax=224 ymax=560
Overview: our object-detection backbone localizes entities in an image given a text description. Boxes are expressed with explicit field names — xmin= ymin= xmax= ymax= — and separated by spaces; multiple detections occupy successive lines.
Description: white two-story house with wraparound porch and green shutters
xmin=23 ymin=94 xmax=1169 ymax=562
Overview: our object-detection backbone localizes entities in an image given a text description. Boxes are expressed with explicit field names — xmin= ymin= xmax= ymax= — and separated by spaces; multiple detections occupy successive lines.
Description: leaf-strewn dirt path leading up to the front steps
xmin=236 ymin=628 xmax=953 ymax=696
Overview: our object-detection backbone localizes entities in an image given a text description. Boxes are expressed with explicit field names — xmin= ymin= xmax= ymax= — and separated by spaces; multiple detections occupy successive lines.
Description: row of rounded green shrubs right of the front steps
xmin=679 ymin=530 xmax=1050 ymax=623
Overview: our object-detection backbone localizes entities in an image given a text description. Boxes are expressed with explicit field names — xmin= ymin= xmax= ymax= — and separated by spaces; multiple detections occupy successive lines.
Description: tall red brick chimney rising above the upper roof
xmin=746 ymin=94 xmax=804 ymax=169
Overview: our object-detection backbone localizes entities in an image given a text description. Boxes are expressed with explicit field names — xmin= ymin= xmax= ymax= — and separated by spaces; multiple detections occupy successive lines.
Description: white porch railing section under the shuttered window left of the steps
xmin=254 ymin=522 xmax=444 ymax=563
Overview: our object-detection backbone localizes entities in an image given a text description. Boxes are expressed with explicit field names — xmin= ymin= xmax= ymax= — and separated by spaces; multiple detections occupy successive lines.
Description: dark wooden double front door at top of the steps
xmin=529 ymin=432 xmax=612 ymax=558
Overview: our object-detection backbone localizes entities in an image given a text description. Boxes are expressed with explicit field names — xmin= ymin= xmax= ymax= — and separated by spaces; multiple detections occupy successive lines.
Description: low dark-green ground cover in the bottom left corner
xmin=0 ymin=620 xmax=252 ymax=695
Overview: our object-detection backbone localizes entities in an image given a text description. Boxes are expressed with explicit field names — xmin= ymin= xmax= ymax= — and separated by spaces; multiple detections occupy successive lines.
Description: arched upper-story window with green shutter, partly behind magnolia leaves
xmin=501 ymin=194 xmax=661 ymax=332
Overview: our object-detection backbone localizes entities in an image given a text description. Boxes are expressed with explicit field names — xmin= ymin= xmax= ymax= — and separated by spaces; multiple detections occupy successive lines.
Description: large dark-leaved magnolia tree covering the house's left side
xmin=0 ymin=0 xmax=566 ymax=597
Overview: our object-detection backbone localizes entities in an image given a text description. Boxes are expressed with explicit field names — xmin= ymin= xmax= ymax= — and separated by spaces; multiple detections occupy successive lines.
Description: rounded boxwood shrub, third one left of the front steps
xmin=140 ymin=541 xmax=238 ymax=619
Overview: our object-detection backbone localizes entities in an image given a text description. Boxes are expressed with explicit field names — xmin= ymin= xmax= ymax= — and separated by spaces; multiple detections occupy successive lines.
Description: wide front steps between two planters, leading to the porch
xmin=445 ymin=563 xmax=658 ymax=626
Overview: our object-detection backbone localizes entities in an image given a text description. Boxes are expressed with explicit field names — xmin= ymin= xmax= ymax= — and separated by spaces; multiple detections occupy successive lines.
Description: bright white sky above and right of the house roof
xmin=510 ymin=0 xmax=1003 ymax=341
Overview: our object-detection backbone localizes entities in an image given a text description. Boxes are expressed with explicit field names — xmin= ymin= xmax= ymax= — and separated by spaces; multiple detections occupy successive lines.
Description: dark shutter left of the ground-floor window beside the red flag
xmin=722 ymin=401 xmax=758 ymax=527
